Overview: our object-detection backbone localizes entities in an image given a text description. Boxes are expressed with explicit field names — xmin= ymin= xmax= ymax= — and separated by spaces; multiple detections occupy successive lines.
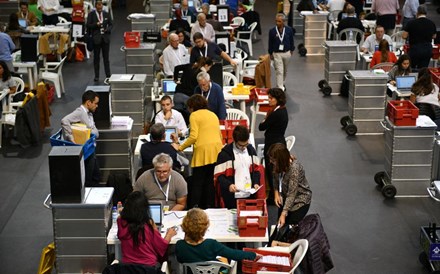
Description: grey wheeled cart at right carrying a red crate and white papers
xmin=374 ymin=117 xmax=436 ymax=198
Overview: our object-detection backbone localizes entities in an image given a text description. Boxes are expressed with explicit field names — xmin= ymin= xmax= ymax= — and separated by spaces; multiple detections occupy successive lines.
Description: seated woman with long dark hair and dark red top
xmin=117 ymin=191 xmax=177 ymax=267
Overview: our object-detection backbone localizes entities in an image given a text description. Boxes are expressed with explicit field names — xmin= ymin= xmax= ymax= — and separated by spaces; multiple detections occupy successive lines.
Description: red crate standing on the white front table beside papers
xmin=237 ymin=199 xmax=267 ymax=237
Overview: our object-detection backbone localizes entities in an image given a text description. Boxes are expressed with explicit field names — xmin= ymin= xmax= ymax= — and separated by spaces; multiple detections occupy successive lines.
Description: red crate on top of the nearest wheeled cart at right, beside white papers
xmin=387 ymin=101 xmax=419 ymax=126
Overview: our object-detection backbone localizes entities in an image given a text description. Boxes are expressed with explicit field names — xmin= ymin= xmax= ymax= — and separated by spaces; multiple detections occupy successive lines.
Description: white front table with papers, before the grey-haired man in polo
xmin=107 ymin=208 xmax=268 ymax=260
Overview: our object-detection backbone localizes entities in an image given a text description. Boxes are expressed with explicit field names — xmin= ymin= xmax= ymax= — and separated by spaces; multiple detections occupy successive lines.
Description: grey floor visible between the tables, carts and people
xmin=0 ymin=0 xmax=440 ymax=274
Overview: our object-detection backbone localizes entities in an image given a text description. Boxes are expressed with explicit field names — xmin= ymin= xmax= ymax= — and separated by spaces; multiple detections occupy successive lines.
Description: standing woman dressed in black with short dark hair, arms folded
xmin=258 ymin=88 xmax=289 ymax=202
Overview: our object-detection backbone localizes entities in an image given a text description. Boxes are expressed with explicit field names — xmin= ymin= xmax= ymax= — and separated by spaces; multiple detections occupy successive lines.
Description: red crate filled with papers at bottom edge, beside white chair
xmin=241 ymin=247 xmax=293 ymax=274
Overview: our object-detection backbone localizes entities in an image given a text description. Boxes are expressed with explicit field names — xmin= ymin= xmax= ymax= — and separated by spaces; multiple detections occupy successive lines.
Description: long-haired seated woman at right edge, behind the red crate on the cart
xmin=410 ymin=68 xmax=440 ymax=125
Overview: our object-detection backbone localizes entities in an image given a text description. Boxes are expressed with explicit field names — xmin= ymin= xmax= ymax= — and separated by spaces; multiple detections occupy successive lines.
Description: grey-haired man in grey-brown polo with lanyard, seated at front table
xmin=133 ymin=153 xmax=188 ymax=211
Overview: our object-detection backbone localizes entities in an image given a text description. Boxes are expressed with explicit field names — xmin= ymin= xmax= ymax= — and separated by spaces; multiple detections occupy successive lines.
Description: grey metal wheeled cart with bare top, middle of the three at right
xmin=340 ymin=70 xmax=388 ymax=136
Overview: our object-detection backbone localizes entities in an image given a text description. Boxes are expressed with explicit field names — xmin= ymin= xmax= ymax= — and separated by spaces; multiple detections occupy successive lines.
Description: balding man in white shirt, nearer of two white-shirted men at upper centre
xmin=163 ymin=33 xmax=189 ymax=77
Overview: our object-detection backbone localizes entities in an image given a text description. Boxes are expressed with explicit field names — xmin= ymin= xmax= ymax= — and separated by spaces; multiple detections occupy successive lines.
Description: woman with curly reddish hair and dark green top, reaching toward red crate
xmin=176 ymin=208 xmax=257 ymax=263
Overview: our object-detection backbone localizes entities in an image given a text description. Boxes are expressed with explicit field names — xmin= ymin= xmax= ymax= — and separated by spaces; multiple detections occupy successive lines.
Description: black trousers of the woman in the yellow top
xmin=188 ymin=164 xmax=215 ymax=209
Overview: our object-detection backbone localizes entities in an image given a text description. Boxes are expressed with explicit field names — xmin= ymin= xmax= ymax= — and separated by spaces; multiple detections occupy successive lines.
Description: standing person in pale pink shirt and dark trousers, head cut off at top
xmin=371 ymin=0 xmax=400 ymax=35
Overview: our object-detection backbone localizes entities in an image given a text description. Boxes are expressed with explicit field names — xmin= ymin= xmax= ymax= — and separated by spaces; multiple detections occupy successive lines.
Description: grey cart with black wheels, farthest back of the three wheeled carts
xmin=318 ymin=41 xmax=358 ymax=96
